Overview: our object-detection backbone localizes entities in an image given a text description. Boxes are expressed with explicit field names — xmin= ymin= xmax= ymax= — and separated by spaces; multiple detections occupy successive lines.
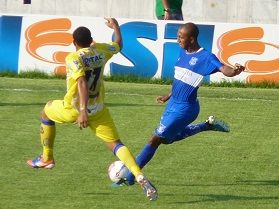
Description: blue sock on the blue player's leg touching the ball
xmin=126 ymin=144 xmax=158 ymax=185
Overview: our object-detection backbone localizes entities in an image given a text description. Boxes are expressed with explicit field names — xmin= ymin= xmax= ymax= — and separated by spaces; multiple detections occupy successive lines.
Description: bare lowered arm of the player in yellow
xmin=77 ymin=76 xmax=89 ymax=129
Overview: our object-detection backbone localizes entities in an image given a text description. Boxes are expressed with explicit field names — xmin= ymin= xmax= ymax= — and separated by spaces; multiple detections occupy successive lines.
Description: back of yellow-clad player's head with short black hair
xmin=73 ymin=26 xmax=92 ymax=47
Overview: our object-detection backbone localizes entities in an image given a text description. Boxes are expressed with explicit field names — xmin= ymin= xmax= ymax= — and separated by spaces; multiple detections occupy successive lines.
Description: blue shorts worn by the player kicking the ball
xmin=155 ymin=99 xmax=200 ymax=144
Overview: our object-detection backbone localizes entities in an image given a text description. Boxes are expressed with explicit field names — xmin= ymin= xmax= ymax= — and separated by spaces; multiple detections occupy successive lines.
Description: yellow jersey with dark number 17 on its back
xmin=64 ymin=42 xmax=120 ymax=114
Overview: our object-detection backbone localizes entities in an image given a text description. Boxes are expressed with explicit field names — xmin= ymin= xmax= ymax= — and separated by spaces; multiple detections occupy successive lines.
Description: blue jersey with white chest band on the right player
xmin=172 ymin=48 xmax=223 ymax=102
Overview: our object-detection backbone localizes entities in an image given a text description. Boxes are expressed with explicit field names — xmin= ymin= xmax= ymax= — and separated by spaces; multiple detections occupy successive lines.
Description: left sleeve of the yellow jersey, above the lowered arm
xmin=66 ymin=52 xmax=85 ymax=80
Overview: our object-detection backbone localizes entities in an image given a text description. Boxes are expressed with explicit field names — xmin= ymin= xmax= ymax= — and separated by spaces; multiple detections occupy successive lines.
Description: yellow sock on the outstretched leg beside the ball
xmin=115 ymin=146 xmax=142 ymax=176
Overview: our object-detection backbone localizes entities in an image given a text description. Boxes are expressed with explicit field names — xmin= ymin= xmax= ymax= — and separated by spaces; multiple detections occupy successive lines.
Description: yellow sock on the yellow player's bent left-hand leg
xmin=40 ymin=123 xmax=55 ymax=161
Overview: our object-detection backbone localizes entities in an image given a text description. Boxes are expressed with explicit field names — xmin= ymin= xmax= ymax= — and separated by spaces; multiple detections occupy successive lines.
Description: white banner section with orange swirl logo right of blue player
xmin=213 ymin=24 xmax=279 ymax=83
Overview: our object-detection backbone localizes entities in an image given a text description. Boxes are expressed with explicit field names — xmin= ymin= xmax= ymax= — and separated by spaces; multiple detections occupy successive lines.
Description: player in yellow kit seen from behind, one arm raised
xmin=27 ymin=18 xmax=157 ymax=200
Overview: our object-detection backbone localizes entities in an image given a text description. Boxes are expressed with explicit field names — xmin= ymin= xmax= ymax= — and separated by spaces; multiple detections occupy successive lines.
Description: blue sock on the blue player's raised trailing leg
xmin=175 ymin=123 xmax=210 ymax=141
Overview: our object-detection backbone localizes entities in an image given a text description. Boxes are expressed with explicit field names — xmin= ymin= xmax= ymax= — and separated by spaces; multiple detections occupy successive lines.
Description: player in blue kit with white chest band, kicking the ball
xmin=119 ymin=23 xmax=245 ymax=185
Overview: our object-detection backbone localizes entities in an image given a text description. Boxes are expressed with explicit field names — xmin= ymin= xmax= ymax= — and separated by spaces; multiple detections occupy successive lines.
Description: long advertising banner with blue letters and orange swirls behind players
xmin=0 ymin=15 xmax=279 ymax=83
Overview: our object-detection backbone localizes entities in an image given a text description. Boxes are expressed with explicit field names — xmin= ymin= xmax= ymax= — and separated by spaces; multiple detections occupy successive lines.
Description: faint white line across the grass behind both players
xmin=0 ymin=88 xmax=279 ymax=102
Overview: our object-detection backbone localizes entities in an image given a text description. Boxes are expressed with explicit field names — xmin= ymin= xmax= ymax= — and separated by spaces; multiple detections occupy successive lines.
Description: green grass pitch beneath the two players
xmin=0 ymin=78 xmax=279 ymax=209
